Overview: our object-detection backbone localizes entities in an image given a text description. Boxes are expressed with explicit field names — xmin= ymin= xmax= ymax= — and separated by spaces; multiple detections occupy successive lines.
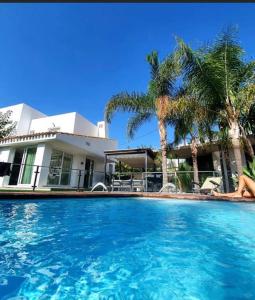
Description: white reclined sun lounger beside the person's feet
xmin=192 ymin=177 xmax=222 ymax=195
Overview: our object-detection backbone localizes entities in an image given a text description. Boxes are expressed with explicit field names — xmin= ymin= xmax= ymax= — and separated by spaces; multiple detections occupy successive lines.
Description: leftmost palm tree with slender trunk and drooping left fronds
xmin=105 ymin=51 xmax=179 ymax=184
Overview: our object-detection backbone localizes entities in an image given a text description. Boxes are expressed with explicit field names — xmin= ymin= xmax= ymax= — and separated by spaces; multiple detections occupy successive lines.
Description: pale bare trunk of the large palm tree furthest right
xmin=229 ymin=118 xmax=243 ymax=176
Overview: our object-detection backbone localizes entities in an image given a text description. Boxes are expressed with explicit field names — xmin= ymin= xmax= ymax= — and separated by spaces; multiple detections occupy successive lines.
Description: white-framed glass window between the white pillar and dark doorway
xmin=48 ymin=150 xmax=73 ymax=185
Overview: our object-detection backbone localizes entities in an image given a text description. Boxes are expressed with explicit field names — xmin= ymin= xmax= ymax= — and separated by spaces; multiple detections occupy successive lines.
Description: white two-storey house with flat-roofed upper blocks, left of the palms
xmin=0 ymin=103 xmax=117 ymax=188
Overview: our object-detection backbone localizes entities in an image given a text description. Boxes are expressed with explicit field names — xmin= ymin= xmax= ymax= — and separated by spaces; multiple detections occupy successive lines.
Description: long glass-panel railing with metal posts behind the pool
xmin=0 ymin=163 xmax=221 ymax=193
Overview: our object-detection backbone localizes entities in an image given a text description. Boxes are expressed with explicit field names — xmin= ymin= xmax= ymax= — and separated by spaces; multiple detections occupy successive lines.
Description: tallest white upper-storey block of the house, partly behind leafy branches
xmin=0 ymin=103 xmax=45 ymax=135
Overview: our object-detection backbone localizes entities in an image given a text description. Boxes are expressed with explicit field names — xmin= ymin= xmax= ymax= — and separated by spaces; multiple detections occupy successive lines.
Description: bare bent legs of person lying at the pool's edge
xmin=213 ymin=175 xmax=255 ymax=198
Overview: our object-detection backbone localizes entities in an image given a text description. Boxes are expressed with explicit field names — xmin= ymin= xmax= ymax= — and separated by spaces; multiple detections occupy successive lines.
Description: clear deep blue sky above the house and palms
xmin=0 ymin=3 xmax=255 ymax=148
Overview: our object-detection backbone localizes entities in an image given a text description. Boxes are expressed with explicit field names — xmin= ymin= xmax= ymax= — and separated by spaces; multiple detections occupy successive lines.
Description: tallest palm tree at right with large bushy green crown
xmin=177 ymin=29 xmax=255 ymax=175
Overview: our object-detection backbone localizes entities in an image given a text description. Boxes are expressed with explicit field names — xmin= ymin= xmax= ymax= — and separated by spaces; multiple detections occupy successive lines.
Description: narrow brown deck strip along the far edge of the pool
xmin=0 ymin=191 xmax=255 ymax=203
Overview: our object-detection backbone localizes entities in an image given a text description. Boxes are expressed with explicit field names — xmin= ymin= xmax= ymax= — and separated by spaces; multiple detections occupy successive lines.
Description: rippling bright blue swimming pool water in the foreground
xmin=0 ymin=199 xmax=255 ymax=300
